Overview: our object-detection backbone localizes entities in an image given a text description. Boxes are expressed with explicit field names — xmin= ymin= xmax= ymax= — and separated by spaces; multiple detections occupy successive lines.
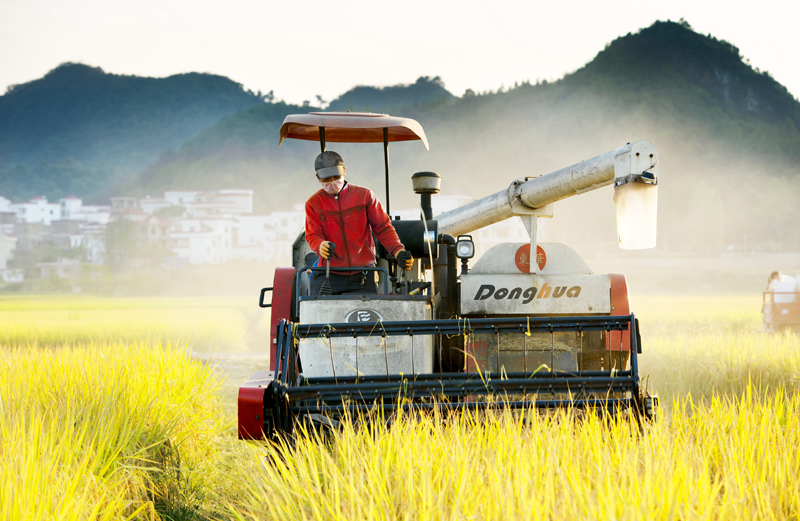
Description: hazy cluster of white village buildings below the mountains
xmin=0 ymin=189 xmax=529 ymax=278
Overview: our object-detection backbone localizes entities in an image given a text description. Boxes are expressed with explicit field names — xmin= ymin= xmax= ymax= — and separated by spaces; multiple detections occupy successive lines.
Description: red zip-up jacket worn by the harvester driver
xmin=306 ymin=183 xmax=405 ymax=268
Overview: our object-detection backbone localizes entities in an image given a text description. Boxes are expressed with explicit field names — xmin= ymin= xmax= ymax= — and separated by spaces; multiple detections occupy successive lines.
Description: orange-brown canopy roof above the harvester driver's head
xmin=278 ymin=112 xmax=428 ymax=150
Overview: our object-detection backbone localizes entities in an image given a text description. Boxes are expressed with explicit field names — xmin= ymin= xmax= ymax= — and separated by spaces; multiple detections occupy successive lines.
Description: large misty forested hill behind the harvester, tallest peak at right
xmin=134 ymin=22 xmax=800 ymax=251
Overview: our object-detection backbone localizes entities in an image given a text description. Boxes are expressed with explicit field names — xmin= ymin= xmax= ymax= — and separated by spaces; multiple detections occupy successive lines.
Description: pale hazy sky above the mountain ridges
xmin=0 ymin=0 xmax=800 ymax=103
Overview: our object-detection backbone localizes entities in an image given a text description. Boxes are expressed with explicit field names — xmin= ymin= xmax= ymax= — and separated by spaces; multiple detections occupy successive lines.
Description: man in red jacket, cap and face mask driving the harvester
xmin=306 ymin=151 xmax=413 ymax=295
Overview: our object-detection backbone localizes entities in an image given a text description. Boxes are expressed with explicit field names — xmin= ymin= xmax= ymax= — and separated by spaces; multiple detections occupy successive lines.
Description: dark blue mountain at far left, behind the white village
xmin=0 ymin=63 xmax=264 ymax=201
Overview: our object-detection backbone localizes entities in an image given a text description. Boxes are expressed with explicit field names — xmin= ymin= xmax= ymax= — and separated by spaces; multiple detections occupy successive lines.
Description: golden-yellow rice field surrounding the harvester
xmin=0 ymin=294 xmax=800 ymax=520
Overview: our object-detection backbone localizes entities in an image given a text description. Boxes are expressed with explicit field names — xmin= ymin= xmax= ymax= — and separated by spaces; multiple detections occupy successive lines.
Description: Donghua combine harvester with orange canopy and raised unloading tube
xmin=238 ymin=113 xmax=658 ymax=439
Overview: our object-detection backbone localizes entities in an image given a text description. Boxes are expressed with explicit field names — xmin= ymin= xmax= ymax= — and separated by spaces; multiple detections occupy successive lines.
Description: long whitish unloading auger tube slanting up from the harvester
xmin=436 ymin=140 xmax=658 ymax=237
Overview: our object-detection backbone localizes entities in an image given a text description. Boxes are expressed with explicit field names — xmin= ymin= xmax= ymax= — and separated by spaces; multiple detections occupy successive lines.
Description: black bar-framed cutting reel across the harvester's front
xmin=256 ymin=315 xmax=646 ymax=432
